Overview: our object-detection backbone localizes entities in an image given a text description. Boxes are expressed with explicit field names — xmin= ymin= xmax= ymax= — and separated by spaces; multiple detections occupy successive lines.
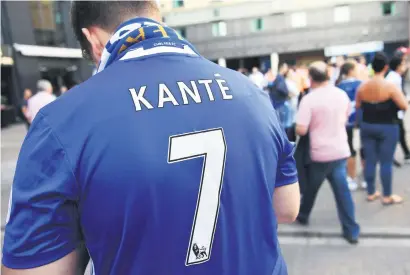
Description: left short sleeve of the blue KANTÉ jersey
xmin=3 ymin=113 xmax=81 ymax=269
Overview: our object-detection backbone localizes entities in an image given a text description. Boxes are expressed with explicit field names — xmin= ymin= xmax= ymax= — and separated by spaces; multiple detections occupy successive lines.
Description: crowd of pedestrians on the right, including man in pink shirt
xmin=247 ymin=48 xmax=410 ymax=243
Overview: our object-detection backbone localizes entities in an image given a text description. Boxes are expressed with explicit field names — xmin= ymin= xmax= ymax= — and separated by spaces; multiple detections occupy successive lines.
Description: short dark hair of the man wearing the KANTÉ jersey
xmin=71 ymin=1 xmax=159 ymax=58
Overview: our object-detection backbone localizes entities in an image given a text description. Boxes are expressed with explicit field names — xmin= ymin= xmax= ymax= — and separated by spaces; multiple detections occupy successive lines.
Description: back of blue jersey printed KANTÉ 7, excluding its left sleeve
xmin=4 ymin=51 xmax=297 ymax=275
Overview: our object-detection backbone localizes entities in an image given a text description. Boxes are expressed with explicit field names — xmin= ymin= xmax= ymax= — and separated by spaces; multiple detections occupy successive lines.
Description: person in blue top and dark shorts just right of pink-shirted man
xmin=337 ymin=60 xmax=367 ymax=191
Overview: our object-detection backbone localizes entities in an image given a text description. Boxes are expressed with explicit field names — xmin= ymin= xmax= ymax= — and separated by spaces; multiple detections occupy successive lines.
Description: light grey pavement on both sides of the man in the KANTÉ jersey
xmin=0 ymin=119 xmax=410 ymax=275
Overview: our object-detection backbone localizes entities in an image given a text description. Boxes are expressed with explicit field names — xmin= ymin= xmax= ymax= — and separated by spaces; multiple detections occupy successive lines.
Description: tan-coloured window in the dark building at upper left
xmin=29 ymin=1 xmax=65 ymax=46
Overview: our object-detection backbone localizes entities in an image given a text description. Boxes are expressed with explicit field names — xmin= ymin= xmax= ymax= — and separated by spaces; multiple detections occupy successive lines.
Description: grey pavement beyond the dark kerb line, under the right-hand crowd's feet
xmin=279 ymin=151 xmax=410 ymax=239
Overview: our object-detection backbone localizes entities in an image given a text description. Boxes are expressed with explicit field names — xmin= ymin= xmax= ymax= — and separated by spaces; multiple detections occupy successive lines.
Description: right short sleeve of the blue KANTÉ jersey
xmin=275 ymin=128 xmax=298 ymax=188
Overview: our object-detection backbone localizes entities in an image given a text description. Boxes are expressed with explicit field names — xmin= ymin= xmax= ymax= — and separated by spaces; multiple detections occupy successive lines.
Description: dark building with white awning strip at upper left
xmin=1 ymin=1 xmax=93 ymax=126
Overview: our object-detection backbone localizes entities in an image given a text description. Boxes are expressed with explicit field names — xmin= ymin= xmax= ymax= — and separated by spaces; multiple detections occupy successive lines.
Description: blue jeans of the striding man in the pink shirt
xmin=298 ymin=159 xmax=360 ymax=238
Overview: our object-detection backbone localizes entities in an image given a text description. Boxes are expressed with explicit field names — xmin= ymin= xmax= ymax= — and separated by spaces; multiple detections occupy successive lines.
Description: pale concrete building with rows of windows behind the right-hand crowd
xmin=160 ymin=0 xmax=410 ymax=69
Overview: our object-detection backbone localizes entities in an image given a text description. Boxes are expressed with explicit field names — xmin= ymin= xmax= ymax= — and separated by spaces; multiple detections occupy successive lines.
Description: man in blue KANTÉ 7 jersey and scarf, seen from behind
xmin=2 ymin=1 xmax=299 ymax=275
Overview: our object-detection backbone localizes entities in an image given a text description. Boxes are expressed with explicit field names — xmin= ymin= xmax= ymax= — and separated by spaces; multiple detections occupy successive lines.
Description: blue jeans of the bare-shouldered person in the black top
xmin=360 ymin=122 xmax=399 ymax=197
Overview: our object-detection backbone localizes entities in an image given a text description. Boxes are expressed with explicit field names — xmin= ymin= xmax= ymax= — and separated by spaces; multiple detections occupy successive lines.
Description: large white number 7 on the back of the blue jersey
xmin=168 ymin=128 xmax=226 ymax=266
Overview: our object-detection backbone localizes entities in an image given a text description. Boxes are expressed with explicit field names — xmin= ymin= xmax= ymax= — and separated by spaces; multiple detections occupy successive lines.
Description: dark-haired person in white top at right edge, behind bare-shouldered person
xmin=386 ymin=55 xmax=410 ymax=163
